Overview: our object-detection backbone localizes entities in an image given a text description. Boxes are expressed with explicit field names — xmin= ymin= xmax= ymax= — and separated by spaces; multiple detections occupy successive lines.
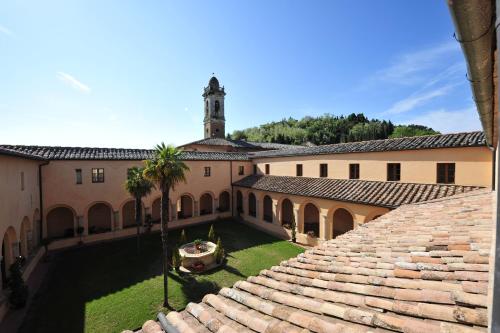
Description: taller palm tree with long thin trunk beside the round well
xmin=144 ymin=142 xmax=189 ymax=308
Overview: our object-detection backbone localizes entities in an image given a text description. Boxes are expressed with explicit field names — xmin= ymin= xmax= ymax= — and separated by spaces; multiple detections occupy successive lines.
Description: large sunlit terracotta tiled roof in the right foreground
xmin=132 ymin=190 xmax=493 ymax=333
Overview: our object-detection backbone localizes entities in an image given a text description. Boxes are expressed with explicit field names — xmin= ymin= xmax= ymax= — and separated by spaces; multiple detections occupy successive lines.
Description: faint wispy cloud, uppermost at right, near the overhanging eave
xmin=375 ymin=41 xmax=460 ymax=85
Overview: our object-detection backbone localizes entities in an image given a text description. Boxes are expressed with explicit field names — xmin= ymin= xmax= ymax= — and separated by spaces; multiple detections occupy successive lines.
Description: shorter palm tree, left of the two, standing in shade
xmin=125 ymin=167 xmax=154 ymax=253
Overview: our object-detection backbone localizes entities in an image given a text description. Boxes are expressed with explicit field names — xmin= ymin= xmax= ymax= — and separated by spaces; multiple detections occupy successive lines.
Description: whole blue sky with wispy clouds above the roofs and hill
xmin=0 ymin=0 xmax=480 ymax=148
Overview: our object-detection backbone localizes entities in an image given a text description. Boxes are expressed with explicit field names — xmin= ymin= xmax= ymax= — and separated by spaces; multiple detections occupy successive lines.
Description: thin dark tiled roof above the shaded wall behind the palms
xmin=0 ymin=145 xmax=248 ymax=161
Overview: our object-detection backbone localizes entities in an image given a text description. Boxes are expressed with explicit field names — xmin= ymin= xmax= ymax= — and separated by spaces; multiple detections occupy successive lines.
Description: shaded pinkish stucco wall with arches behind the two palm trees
xmin=42 ymin=160 xmax=252 ymax=235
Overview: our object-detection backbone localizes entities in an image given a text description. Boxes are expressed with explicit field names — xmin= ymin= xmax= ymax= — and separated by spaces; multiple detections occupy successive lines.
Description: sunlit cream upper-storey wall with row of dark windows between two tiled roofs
xmin=254 ymin=147 xmax=493 ymax=187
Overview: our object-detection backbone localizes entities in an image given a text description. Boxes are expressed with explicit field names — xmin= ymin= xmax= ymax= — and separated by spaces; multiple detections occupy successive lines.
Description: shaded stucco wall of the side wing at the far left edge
xmin=0 ymin=156 xmax=40 ymax=298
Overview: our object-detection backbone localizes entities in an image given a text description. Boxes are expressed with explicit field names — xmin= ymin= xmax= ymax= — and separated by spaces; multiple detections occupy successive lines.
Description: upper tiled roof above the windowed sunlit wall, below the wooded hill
xmin=251 ymin=132 xmax=486 ymax=158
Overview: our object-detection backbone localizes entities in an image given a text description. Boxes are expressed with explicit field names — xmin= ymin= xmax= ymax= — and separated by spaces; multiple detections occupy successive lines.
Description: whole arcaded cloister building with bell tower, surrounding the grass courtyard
xmin=0 ymin=78 xmax=494 ymax=318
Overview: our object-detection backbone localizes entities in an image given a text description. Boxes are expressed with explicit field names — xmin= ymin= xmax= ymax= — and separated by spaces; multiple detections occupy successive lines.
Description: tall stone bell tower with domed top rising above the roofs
xmin=202 ymin=76 xmax=226 ymax=139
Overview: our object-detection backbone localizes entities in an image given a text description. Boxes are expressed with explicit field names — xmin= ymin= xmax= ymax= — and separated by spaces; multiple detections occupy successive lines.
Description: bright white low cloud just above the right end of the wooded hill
xmin=401 ymin=106 xmax=481 ymax=133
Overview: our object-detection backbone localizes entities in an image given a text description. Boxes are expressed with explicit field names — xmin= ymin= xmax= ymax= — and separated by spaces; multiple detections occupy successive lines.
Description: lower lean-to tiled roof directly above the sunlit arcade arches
xmin=233 ymin=175 xmax=479 ymax=208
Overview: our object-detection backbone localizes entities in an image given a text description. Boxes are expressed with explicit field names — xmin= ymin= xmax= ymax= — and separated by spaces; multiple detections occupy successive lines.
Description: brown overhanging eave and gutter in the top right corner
xmin=447 ymin=0 xmax=496 ymax=148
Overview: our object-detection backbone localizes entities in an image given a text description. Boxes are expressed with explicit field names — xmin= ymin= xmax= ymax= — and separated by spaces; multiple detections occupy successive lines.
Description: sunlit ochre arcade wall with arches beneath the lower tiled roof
xmin=233 ymin=186 xmax=389 ymax=245
